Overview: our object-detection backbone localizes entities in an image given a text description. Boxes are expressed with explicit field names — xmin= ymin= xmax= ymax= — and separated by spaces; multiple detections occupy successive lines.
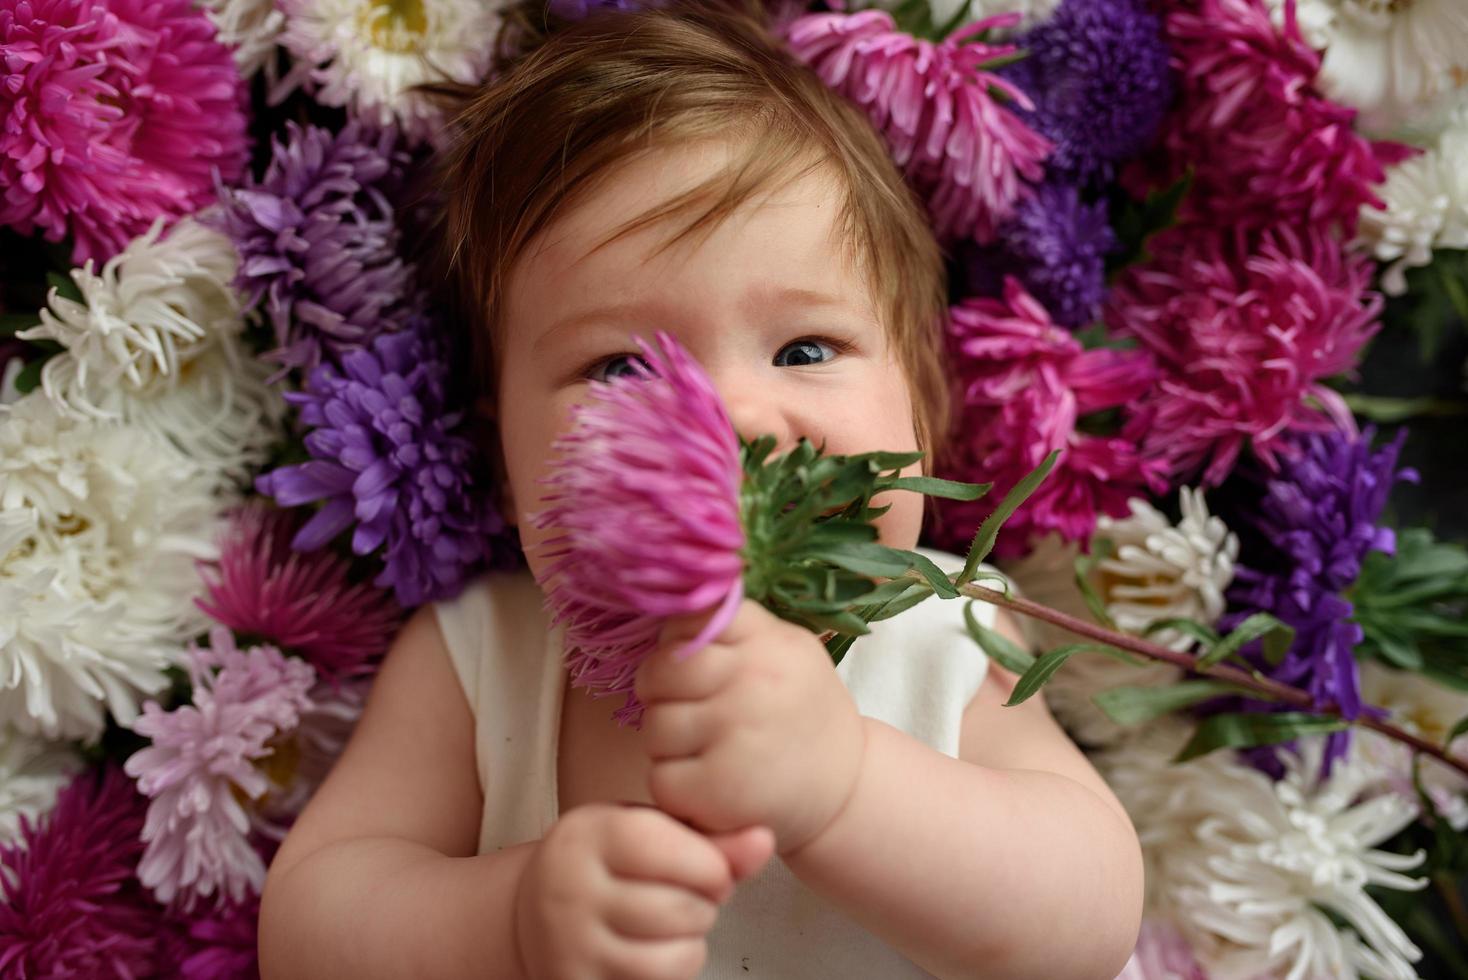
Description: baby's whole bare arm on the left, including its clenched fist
xmin=260 ymin=610 xmax=774 ymax=980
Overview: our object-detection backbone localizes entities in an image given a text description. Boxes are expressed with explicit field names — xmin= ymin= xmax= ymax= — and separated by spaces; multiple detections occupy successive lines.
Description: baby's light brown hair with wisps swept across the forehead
xmin=425 ymin=0 xmax=950 ymax=504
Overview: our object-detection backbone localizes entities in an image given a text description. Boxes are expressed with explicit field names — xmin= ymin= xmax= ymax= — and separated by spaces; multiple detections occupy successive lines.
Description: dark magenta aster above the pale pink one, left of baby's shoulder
xmin=195 ymin=500 xmax=402 ymax=685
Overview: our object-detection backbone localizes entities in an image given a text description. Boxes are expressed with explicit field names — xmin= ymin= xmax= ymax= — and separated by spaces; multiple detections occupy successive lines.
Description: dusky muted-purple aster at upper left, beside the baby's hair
xmin=213 ymin=122 xmax=413 ymax=370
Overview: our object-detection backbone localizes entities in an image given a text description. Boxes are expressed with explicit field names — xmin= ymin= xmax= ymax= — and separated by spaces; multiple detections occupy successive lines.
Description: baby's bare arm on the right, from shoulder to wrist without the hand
xmin=781 ymin=612 xmax=1142 ymax=980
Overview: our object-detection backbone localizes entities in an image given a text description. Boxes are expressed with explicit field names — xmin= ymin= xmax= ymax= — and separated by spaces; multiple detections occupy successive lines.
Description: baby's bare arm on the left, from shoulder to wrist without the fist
xmin=260 ymin=609 xmax=533 ymax=980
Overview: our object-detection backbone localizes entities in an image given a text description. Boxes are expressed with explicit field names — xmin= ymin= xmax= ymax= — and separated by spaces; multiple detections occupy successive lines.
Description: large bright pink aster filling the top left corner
xmin=0 ymin=0 xmax=248 ymax=264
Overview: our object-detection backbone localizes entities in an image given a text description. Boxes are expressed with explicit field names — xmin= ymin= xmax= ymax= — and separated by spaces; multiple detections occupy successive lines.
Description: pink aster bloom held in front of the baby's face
xmin=530 ymin=332 xmax=744 ymax=725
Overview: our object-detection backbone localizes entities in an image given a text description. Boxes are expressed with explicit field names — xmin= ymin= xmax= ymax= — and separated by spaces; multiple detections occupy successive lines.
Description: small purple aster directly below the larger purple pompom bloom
xmin=964 ymin=183 xmax=1117 ymax=327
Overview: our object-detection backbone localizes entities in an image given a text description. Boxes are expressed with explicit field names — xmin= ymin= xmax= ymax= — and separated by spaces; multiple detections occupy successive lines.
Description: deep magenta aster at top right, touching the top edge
xmin=1132 ymin=0 xmax=1415 ymax=236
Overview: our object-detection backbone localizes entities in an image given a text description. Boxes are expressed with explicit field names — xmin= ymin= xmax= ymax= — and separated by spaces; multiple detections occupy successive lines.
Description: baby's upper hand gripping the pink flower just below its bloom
xmin=636 ymin=599 xmax=866 ymax=854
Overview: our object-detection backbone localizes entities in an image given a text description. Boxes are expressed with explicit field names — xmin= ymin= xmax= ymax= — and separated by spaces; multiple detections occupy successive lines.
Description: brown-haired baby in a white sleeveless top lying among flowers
xmin=260 ymin=1 xmax=1142 ymax=980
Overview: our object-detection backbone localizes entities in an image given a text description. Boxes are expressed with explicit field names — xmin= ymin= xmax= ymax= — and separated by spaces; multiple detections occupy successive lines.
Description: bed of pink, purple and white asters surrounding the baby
xmin=0 ymin=0 xmax=1468 ymax=980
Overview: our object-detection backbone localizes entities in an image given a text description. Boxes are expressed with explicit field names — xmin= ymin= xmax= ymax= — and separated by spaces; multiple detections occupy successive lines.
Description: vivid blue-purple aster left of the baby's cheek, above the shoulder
xmin=255 ymin=317 xmax=518 ymax=606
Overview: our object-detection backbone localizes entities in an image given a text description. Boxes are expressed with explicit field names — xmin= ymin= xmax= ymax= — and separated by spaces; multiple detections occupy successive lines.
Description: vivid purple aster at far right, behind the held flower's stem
xmin=1223 ymin=428 xmax=1417 ymax=776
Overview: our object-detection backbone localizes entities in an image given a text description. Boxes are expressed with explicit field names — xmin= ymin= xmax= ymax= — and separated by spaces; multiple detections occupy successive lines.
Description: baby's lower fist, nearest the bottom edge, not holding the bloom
xmin=515 ymin=804 xmax=774 ymax=980
